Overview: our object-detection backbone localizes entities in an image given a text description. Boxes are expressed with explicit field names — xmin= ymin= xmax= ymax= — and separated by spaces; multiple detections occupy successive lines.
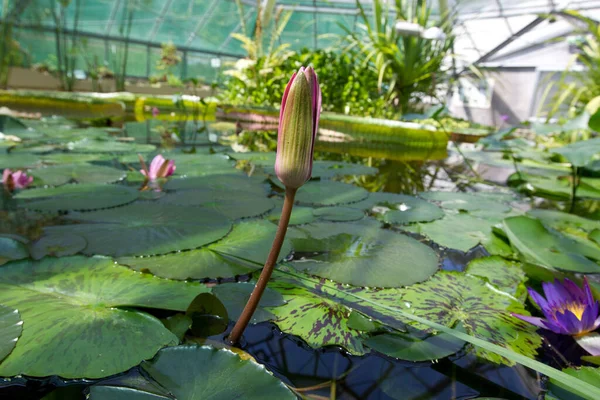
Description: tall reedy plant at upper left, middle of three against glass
xmin=50 ymin=0 xmax=81 ymax=92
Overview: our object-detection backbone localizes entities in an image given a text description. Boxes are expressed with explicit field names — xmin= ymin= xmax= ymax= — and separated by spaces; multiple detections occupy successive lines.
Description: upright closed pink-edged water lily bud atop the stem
xmin=275 ymin=67 xmax=321 ymax=189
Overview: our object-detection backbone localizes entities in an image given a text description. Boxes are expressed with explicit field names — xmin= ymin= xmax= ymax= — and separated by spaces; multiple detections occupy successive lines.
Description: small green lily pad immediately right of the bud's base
xmin=296 ymin=181 xmax=369 ymax=206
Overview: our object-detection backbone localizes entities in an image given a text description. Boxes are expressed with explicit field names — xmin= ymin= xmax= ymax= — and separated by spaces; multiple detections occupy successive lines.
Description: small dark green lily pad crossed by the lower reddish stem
xmin=212 ymin=282 xmax=285 ymax=324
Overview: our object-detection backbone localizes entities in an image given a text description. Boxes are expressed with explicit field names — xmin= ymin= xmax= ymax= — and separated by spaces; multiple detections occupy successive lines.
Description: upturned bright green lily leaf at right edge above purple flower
xmin=503 ymin=216 xmax=600 ymax=273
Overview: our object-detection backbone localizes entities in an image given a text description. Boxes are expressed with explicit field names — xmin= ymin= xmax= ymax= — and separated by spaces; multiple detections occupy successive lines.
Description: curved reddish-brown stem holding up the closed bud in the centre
xmin=227 ymin=187 xmax=298 ymax=345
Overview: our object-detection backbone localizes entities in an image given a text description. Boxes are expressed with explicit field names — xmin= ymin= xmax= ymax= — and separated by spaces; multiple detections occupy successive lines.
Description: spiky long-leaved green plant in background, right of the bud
xmin=343 ymin=0 xmax=454 ymax=114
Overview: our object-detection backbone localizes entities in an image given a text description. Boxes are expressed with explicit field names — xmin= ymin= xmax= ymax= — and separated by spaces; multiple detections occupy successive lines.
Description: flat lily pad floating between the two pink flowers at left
xmin=31 ymin=164 xmax=127 ymax=186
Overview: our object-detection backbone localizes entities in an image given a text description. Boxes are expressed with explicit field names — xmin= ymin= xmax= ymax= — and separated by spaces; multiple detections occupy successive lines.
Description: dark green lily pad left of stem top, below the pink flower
xmin=159 ymin=188 xmax=275 ymax=220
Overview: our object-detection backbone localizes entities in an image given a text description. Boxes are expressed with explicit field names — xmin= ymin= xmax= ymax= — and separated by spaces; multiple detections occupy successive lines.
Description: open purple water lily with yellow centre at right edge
xmin=512 ymin=278 xmax=600 ymax=336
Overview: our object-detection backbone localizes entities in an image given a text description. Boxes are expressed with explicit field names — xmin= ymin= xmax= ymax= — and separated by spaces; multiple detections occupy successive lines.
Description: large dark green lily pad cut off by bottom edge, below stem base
xmin=90 ymin=346 xmax=296 ymax=400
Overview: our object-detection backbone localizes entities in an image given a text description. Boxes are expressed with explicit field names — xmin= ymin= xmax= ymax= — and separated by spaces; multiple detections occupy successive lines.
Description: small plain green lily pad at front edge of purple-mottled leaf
xmin=365 ymin=330 xmax=465 ymax=361
